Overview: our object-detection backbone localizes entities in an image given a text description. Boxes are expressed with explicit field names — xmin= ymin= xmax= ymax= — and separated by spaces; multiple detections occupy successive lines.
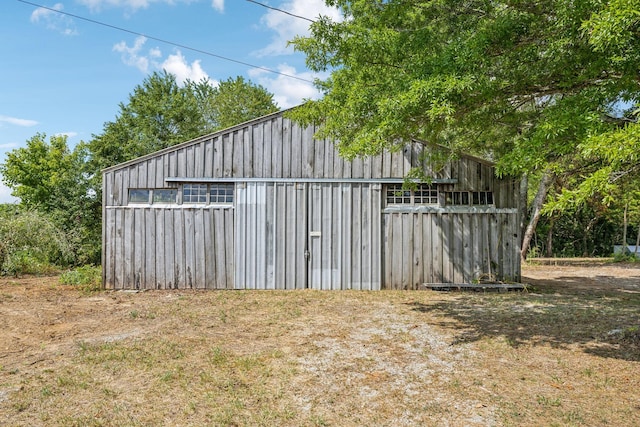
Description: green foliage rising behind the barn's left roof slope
xmin=89 ymin=71 xmax=277 ymax=171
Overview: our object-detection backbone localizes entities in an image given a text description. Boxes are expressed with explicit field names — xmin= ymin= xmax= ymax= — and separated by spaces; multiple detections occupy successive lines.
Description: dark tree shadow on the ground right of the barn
xmin=409 ymin=277 xmax=640 ymax=361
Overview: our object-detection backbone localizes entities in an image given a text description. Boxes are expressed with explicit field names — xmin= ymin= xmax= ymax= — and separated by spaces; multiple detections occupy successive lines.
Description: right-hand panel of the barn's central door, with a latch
xmin=307 ymin=183 xmax=382 ymax=289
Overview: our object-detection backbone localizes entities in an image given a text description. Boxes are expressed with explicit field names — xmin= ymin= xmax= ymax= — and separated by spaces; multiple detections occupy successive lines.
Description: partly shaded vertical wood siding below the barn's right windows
xmin=383 ymin=212 xmax=520 ymax=289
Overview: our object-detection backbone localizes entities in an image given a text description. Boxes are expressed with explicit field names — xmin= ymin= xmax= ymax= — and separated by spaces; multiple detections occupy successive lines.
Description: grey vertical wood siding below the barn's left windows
xmin=103 ymin=208 xmax=234 ymax=289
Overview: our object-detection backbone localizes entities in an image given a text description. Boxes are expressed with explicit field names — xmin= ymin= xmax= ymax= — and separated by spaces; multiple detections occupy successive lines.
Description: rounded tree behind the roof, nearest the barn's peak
xmin=187 ymin=76 xmax=279 ymax=132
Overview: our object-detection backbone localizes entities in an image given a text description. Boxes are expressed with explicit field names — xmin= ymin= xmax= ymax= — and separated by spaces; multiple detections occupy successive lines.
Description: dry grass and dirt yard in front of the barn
xmin=0 ymin=262 xmax=640 ymax=426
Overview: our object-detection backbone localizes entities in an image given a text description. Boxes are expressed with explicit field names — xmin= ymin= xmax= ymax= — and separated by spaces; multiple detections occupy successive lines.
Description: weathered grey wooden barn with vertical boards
xmin=102 ymin=108 xmax=520 ymax=290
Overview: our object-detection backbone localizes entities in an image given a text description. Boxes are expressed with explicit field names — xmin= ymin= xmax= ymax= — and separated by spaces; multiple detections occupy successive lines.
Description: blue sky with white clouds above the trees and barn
xmin=0 ymin=0 xmax=339 ymax=203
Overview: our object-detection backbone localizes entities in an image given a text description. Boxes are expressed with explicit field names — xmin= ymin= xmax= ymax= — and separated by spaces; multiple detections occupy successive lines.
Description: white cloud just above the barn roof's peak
xmin=249 ymin=64 xmax=321 ymax=108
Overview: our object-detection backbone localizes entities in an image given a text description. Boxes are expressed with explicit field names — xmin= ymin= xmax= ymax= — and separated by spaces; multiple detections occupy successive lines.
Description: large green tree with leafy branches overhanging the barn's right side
xmin=291 ymin=0 xmax=640 ymax=255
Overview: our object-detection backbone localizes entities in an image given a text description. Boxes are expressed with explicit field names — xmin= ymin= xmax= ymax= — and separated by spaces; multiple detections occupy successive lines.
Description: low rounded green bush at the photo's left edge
xmin=0 ymin=209 xmax=73 ymax=275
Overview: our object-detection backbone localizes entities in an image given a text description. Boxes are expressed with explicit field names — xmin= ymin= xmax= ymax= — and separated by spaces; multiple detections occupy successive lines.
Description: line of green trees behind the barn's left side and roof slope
xmin=0 ymin=72 xmax=277 ymax=268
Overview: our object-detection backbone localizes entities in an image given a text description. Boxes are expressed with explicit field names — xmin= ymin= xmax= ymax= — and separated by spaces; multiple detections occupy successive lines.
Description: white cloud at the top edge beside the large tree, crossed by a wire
xmin=256 ymin=0 xmax=342 ymax=56
